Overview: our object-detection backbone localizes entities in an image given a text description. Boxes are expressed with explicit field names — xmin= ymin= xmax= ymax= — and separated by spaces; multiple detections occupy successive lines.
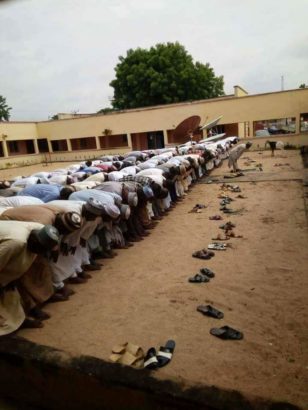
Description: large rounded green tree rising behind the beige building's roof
xmin=110 ymin=43 xmax=224 ymax=109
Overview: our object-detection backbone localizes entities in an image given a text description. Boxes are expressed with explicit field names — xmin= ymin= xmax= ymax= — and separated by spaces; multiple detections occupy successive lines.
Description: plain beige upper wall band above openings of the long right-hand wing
xmin=31 ymin=89 xmax=308 ymax=139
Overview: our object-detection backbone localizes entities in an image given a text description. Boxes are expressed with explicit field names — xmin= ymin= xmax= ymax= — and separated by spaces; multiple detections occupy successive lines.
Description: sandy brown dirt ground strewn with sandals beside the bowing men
xmin=0 ymin=151 xmax=308 ymax=409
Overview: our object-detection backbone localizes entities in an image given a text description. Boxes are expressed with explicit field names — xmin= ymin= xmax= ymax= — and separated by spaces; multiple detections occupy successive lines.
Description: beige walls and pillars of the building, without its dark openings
xmin=0 ymin=86 xmax=308 ymax=170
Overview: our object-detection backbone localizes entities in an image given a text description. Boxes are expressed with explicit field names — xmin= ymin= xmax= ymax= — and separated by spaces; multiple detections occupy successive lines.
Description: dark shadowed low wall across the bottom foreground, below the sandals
xmin=0 ymin=335 xmax=299 ymax=410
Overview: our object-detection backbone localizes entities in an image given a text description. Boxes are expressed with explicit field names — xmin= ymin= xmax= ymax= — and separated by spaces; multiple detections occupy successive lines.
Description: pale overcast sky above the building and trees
xmin=0 ymin=0 xmax=308 ymax=121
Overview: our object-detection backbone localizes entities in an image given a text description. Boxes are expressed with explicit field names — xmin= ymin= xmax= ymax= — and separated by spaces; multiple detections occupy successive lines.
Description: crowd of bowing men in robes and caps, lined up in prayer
xmin=0 ymin=136 xmax=238 ymax=335
